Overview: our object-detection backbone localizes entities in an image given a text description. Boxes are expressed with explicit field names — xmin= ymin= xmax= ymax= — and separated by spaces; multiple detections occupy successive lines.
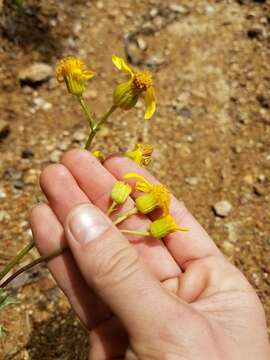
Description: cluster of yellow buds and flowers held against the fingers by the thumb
xmin=107 ymin=173 xmax=188 ymax=239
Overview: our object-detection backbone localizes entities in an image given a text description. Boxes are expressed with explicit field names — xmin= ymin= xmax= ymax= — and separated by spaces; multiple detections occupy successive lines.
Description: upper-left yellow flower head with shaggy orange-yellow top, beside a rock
xmin=56 ymin=56 xmax=95 ymax=96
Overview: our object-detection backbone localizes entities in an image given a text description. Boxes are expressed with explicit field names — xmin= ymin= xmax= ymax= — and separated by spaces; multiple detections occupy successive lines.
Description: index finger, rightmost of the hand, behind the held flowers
xmin=104 ymin=156 xmax=220 ymax=269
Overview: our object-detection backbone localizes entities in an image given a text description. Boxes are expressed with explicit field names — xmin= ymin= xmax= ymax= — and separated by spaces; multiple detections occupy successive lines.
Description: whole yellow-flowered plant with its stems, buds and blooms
xmin=0 ymin=55 xmax=187 ymax=335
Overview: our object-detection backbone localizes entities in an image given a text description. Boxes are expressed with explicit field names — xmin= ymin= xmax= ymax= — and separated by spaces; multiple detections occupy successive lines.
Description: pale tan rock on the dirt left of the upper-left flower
xmin=19 ymin=63 xmax=53 ymax=85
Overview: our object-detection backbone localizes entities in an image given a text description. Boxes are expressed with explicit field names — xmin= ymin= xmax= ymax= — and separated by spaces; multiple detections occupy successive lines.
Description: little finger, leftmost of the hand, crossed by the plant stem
xmin=30 ymin=204 xmax=111 ymax=329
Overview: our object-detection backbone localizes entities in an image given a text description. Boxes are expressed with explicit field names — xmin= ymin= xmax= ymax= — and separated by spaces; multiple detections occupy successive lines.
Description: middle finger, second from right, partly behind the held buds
xmin=62 ymin=150 xmax=180 ymax=280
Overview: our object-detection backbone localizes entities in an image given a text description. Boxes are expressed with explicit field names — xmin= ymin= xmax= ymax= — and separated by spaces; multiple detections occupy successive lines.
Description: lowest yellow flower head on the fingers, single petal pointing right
xmin=149 ymin=214 xmax=188 ymax=239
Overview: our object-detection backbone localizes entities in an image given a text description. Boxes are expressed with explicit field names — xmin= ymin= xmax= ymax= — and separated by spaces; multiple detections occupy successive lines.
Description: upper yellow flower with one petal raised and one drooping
xmin=112 ymin=55 xmax=156 ymax=119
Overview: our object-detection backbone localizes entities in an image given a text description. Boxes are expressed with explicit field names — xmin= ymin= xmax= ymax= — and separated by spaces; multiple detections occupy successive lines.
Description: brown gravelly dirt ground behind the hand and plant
xmin=0 ymin=0 xmax=270 ymax=360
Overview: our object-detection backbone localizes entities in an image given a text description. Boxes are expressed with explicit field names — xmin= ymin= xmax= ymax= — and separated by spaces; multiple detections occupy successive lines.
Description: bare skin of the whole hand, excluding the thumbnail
xmin=30 ymin=150 xmax=270 ymax=360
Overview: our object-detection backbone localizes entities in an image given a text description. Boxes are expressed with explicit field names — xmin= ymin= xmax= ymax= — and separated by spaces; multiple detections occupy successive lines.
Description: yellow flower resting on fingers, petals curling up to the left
xmin=124 ymin=173 xmax=170 ymax=215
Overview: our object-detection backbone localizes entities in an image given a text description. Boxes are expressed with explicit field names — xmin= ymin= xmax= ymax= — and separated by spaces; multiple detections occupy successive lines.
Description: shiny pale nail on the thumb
xmin=67 ymin=204 xmax=109 ymax=243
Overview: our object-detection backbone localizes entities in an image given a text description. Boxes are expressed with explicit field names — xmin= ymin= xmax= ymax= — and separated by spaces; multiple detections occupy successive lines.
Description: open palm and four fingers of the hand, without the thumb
xmin=31 ymin=150 xmax=270 ymax=360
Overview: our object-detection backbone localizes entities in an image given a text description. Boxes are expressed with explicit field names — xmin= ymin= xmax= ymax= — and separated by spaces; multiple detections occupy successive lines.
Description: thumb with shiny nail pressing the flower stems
xmin=65 ymin=204 xmax=169 ymax=331
